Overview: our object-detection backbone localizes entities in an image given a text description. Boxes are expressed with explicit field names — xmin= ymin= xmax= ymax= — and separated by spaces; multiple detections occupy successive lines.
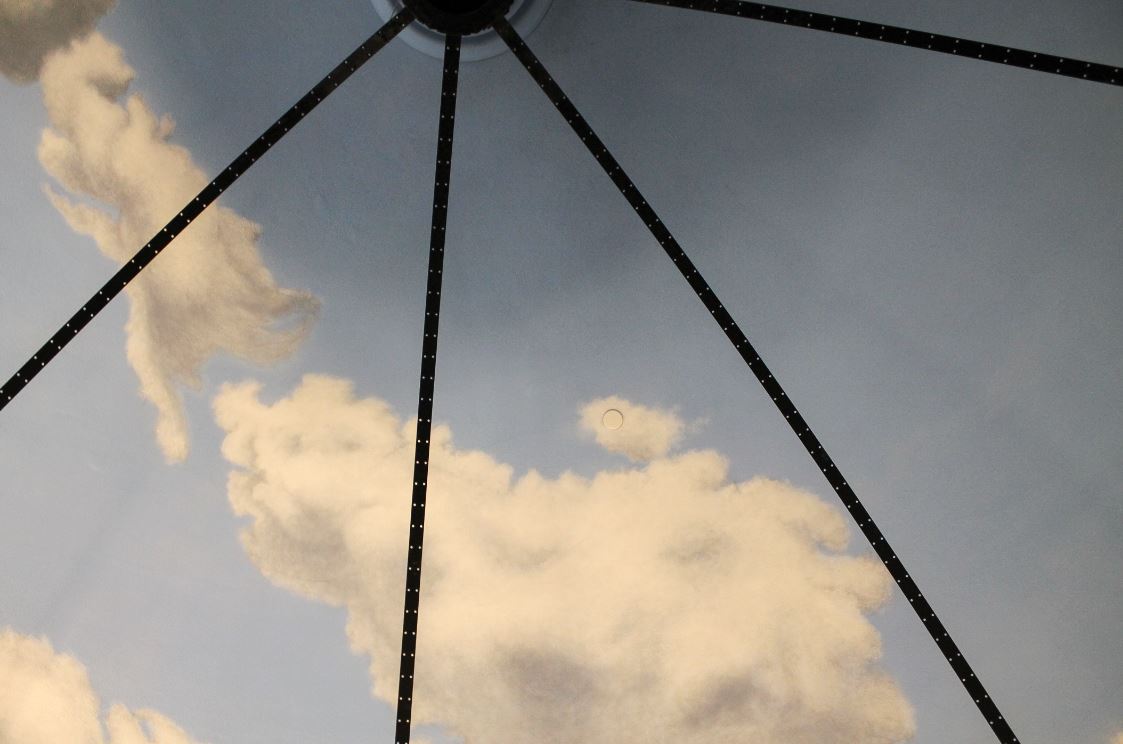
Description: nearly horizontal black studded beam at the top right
xmin=632 ymin=0 xmax=1123 ymax=85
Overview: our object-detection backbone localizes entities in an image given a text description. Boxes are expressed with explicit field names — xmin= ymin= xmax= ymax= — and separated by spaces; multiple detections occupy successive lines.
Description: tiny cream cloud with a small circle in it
xmin=579 ymin=395 xmax=684 ymax=461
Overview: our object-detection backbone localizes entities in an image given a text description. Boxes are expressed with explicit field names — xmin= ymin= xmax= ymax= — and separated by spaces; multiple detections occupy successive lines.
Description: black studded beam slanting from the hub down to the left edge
xmin=0 ymin=10 xmax=413 ymax=410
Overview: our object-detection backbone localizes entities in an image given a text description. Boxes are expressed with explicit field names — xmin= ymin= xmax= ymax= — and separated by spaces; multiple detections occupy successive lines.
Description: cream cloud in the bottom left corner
xmin=0 ymin=628 xmax=202 ymax=744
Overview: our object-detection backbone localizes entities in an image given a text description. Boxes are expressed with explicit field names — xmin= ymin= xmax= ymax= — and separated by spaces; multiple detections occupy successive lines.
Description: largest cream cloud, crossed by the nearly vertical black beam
xmin=214 ymin=376 xmax=914 ymax=744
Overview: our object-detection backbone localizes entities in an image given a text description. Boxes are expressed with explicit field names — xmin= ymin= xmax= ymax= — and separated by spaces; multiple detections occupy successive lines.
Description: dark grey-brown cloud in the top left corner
xmin=0 ymin=0 xmax=115 ymax=83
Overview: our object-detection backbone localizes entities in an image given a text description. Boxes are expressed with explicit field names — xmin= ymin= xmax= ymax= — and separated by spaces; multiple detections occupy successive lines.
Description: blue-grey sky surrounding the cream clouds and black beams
xmin=0 ymin=0 xmax=1123 ymax=744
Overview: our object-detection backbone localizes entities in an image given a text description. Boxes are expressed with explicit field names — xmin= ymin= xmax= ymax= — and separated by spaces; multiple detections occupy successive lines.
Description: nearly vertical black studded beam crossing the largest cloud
xmin=394 ymin=34 xmax=460 ymax=744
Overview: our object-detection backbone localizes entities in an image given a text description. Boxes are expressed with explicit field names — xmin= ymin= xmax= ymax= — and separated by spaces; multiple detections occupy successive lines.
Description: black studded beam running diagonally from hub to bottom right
xmin=494 ymin=19 xmax=1017 ymax=744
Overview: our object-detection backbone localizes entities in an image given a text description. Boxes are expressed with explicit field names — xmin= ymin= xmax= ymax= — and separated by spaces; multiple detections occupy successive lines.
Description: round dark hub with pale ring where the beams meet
xmin=371 ymin=0 xmax=553 ymax=63
